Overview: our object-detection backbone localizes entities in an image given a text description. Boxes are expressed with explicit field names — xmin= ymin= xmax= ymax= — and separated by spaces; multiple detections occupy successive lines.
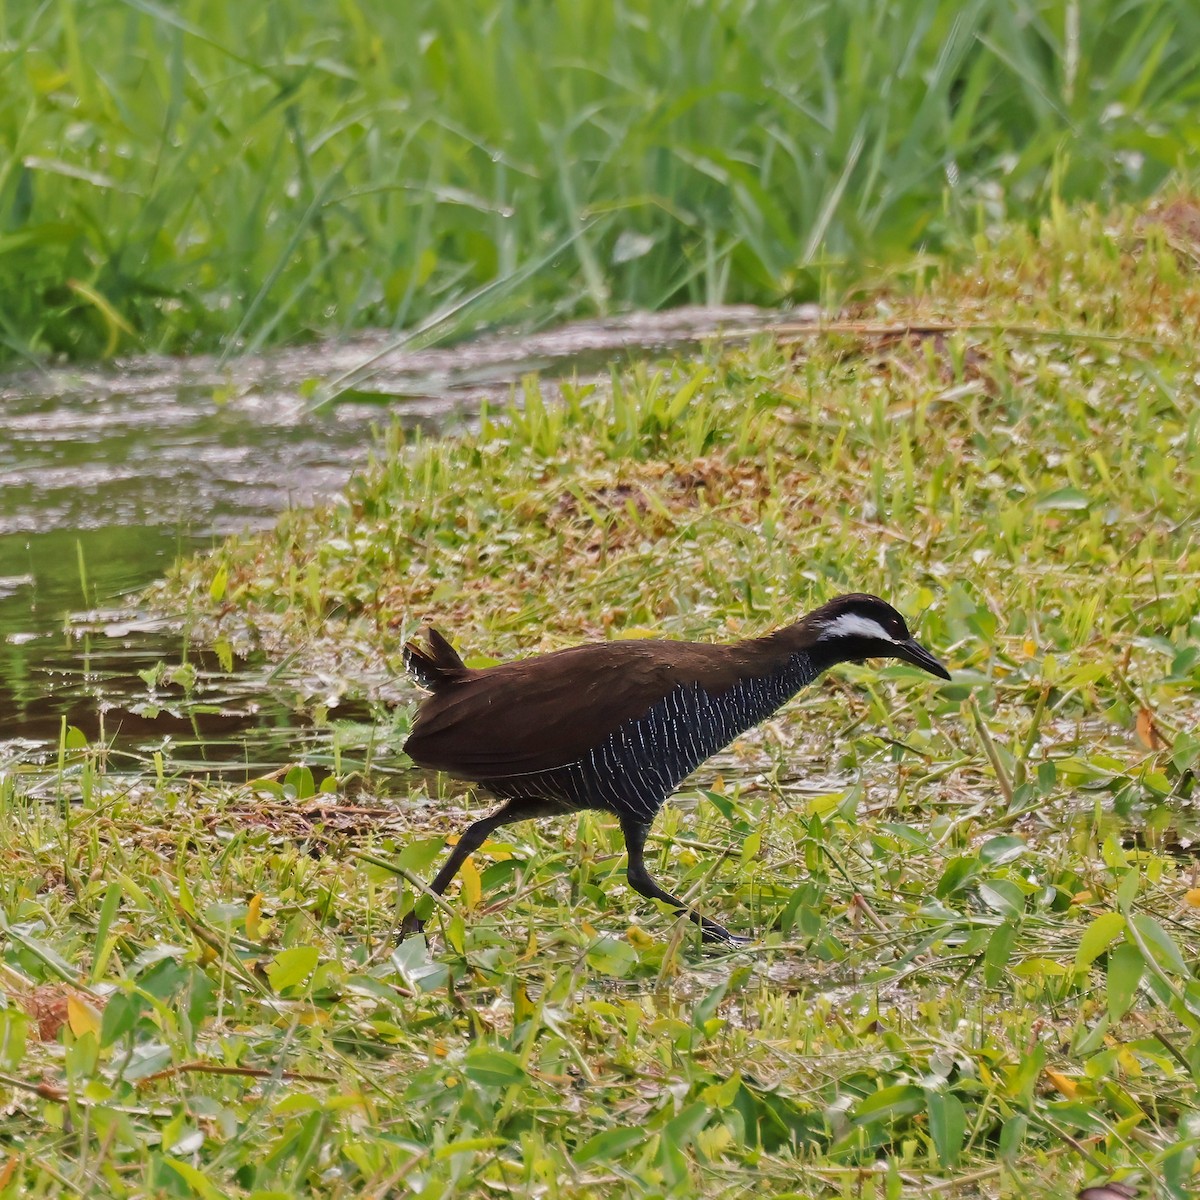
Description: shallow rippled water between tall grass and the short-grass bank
xmin=0 ymin=307 xmax=778 ymax=775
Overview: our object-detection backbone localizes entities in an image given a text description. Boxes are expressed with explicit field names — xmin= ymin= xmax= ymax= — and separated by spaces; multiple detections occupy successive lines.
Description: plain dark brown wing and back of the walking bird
xmin=404 ymin=641 xmax=744 ymax=780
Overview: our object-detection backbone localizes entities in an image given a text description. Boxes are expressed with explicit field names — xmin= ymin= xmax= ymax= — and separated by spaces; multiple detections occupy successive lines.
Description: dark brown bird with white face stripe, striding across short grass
xmin=403 ymin=594 xmax=950 ymax=942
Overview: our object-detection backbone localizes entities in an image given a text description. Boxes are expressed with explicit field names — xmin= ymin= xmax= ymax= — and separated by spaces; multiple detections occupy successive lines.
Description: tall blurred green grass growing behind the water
xmin=0 ymin=0 xmax=1200 ymax=358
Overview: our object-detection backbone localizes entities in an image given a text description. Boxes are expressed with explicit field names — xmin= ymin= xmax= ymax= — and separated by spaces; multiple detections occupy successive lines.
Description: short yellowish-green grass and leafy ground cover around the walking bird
xmin=0 ymin=206 xmax=1200 ymax=1200
